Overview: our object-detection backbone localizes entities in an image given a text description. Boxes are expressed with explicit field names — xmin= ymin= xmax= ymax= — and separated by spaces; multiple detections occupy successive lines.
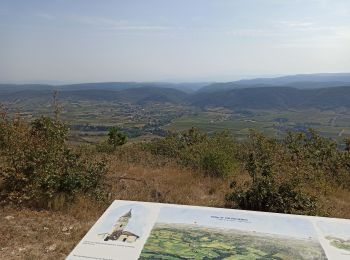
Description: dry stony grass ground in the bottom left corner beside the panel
xmin=0 ymin=202 xmax=97 ymax=259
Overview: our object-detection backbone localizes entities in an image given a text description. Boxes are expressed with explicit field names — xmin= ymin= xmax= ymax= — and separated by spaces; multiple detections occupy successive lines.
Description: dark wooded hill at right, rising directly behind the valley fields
xmin=188 ymin=84 xmax=350 ymax=109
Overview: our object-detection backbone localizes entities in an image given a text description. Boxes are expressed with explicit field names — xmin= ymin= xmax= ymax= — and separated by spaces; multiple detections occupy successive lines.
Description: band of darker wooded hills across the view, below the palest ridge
xmin=0 ymin=83 xmax=350 ymax=109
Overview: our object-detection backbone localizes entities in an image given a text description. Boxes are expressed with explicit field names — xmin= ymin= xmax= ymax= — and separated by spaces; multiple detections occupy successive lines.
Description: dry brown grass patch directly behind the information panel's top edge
xmin=107 ymin=157 xmax=229 ymax=207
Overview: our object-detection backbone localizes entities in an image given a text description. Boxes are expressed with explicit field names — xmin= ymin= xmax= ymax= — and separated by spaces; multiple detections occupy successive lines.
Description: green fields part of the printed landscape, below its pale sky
xmin=139 ymin=223 xmax=327 ymax=260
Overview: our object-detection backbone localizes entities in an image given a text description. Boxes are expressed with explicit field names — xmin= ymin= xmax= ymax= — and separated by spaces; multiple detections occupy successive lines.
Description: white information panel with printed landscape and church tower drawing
xmin=67 ymin=201 xmax=350 ymax=260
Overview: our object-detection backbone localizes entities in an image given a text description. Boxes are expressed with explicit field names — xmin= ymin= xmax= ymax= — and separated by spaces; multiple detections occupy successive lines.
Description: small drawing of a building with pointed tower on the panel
xmin=104 ymin=209 xmax=139 ymax=243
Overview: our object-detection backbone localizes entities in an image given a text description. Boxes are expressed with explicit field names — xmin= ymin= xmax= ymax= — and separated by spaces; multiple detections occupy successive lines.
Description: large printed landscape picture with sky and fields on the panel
xmin=140 ymin=207 xmax=327 ymax=259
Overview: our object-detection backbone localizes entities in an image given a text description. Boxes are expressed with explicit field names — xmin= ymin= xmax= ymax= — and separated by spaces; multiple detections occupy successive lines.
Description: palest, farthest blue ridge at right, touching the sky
xmin=199 ymin=73 xmax=350 ymax=92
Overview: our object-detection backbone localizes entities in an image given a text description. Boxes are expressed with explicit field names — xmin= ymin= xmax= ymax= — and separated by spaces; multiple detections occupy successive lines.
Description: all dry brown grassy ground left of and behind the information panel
xmin=0 ymin=149 xmax=350 ymax=259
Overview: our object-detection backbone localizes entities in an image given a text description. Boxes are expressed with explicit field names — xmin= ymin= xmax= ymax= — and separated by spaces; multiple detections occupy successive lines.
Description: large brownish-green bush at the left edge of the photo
xmin=0 ymin=117 xmax=106 ymax=207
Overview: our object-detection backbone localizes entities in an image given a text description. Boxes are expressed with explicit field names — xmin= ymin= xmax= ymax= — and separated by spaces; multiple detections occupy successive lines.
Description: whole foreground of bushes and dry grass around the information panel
xmin=0 ymin=106 xmax=350 ymax=259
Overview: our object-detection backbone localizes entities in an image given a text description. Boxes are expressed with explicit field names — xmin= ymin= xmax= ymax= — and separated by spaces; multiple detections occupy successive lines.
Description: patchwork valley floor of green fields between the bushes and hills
xmin=6 ymin=97 xmax=350 ymax=143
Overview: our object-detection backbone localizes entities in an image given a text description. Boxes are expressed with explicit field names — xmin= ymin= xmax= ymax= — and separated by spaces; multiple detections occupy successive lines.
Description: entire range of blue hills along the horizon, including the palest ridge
xmin=0 ymin=73 xmax=350 ymax=109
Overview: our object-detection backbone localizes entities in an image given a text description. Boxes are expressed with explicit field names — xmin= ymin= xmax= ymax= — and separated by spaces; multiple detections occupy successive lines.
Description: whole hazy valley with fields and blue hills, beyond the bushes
xmin=0 ymin=73 xmax=350 ymax=142
